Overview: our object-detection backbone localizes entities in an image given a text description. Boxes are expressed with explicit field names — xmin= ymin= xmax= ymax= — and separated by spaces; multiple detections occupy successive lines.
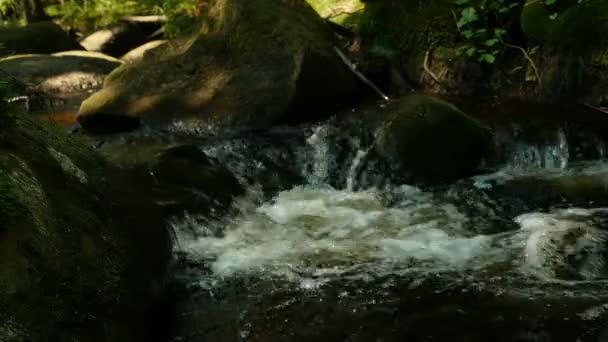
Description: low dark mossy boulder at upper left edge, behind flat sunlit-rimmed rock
xmin=0 ymin=22 xmax=83 ymax=57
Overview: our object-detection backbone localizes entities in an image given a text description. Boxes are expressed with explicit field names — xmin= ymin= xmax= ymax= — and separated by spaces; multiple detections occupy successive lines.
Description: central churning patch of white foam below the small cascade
xmin=170 ymin=187 xmax=491 ymax=277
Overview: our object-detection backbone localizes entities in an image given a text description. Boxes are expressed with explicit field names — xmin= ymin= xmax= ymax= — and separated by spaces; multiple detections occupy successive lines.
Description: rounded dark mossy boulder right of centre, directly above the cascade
xmin=375 ymin=95 xmax=490 ymax=180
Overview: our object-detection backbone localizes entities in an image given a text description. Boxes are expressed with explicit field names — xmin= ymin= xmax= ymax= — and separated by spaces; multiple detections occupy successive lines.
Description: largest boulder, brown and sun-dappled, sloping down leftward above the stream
xmin=79 ymin=0 xmax=356 ymax=131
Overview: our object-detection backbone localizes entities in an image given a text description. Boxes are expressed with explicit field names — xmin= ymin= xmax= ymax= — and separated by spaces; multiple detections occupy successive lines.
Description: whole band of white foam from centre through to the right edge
xmin=175 ymin=182 xmax=608 ymax=287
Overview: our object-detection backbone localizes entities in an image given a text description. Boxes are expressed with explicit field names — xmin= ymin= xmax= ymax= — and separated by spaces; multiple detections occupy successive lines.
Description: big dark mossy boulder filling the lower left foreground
xmin=0 ymin=113 xmax=171 ymax=342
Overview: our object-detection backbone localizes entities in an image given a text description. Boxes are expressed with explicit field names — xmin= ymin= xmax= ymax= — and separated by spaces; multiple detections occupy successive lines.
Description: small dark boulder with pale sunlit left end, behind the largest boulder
xmin=80 ymin=16 xmax=165 ymax=58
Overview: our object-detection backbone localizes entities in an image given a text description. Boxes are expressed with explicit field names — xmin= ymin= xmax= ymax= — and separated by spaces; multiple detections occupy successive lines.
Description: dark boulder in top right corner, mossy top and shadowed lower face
xmin=521 ymin=0 xmax=608 ymax=103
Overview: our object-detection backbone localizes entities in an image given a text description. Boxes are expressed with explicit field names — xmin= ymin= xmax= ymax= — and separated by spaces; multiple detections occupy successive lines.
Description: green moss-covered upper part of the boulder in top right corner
xmin=521 ymin=0 xmax=608 ymax=65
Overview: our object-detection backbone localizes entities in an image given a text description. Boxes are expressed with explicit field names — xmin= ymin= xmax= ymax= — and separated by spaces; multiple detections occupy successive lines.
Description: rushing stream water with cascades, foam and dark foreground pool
xmin=173 ymin=117 xmax=608 ymax=342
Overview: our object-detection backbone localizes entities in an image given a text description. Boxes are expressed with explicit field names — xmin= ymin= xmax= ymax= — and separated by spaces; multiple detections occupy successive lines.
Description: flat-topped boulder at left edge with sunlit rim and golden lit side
xmin=0 ymin=51 xmax=122 ymax=111
